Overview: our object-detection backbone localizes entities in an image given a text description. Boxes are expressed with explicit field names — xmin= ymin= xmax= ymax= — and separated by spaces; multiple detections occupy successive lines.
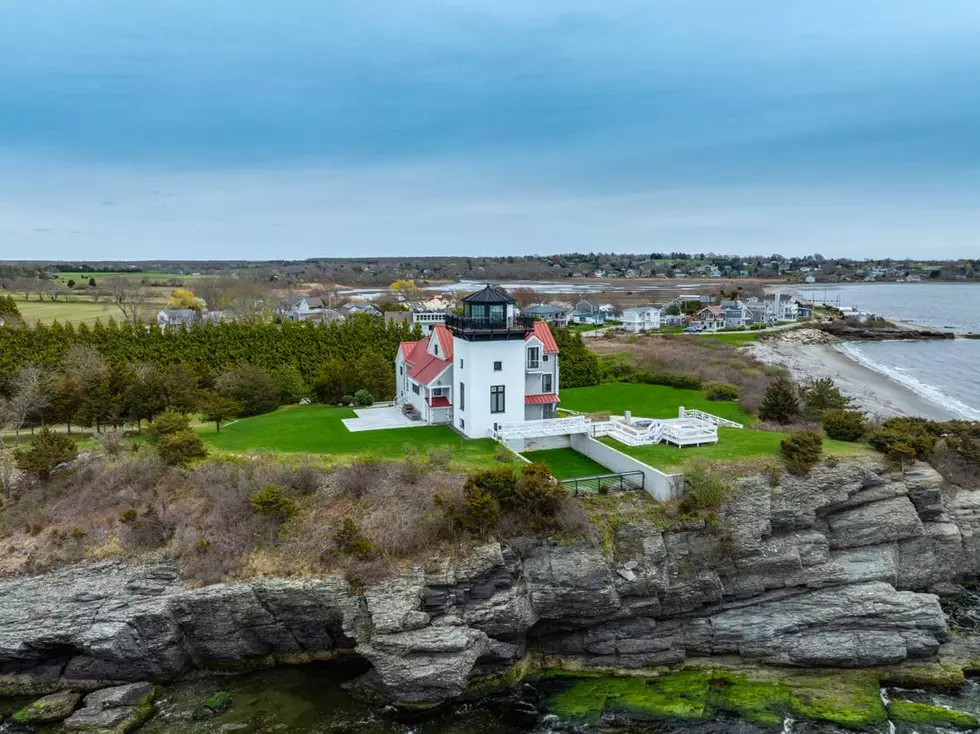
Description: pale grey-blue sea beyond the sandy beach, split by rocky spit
xmin=801 ymin=283 xmax=980 ymax=420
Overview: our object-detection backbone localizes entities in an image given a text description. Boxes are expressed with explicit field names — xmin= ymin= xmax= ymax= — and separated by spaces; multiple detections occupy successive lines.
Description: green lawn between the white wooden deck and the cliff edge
xmin=604 ymin=428 xmax=873 ymax=469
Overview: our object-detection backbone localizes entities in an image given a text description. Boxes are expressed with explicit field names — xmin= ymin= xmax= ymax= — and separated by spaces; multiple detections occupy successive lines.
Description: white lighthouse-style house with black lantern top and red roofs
xmin=395 ymin=285 xmax=558 ymax=438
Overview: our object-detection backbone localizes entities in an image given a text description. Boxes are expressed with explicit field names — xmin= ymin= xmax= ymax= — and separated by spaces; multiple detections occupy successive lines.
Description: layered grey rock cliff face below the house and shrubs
xmin=0 ymin=465 xmax=980 ymax=703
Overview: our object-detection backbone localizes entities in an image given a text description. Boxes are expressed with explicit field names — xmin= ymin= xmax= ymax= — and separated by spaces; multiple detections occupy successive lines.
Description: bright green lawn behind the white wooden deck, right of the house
xmin=561 ymin=382 xmax=754 ymax=425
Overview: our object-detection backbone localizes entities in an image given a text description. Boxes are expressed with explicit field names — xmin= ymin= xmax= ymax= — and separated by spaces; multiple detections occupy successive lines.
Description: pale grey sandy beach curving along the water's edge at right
xmin=751 ymin=340 xmax=957 ymax=420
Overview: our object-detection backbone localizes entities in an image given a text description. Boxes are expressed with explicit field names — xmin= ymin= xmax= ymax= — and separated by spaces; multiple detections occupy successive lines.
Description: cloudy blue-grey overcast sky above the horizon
xmin=0 ymin=0 xmax=980 ymax=259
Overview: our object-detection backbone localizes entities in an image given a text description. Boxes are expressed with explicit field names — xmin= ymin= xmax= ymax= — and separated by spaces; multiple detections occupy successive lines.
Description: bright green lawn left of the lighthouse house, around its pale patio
xmin=198 ymin=405 xmax=496 ymax=467
